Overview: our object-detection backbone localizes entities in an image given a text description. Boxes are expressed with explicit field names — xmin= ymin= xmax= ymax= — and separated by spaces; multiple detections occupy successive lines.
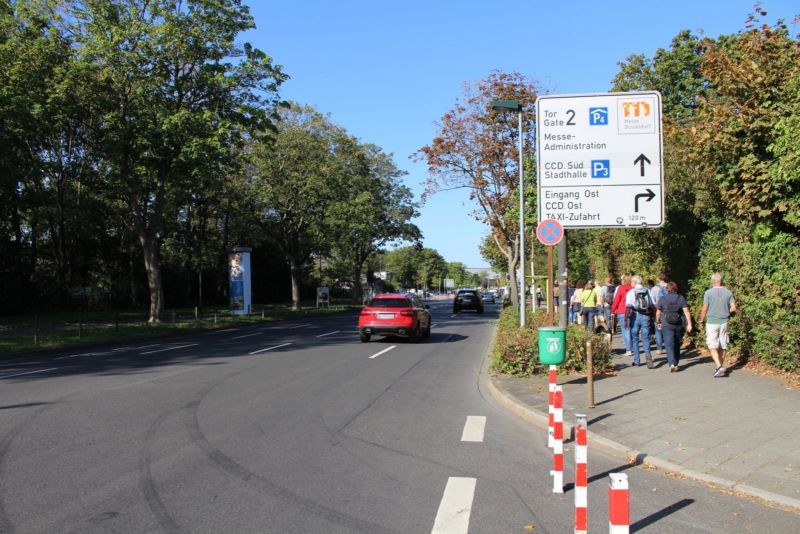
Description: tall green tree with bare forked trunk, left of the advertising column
xmin=66 ymin=0 xmax=285 ymax=322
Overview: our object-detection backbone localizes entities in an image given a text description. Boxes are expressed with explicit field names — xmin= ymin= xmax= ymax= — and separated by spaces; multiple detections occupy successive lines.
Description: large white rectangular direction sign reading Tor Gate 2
xmin=536 ymin=91 xmax=664 ymax=228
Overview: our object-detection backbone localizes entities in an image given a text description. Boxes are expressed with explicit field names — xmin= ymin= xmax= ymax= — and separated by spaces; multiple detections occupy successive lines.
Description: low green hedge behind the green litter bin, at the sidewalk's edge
xmin=492 ymin=306 xmax=612 ymax=376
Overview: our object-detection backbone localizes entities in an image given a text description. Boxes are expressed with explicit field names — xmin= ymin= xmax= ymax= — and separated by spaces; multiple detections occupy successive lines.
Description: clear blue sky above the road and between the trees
xmin=243 ymin=0 xmax=800 ymax=267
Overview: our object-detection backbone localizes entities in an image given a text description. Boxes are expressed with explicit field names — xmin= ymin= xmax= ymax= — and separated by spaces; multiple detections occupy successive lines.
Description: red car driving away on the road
xmin=358 ymin=293 xmax=431 ymax=343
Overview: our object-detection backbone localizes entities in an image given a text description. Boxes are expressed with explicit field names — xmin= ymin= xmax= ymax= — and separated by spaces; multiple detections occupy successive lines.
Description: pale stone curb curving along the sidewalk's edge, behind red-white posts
xmin=486 ymin=375 xmax=800 ymax=513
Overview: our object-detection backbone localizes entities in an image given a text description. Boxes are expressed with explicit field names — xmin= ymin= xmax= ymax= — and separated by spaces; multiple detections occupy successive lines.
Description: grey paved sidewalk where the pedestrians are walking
xmin=489 ymin=334 xmax=800 ymax=511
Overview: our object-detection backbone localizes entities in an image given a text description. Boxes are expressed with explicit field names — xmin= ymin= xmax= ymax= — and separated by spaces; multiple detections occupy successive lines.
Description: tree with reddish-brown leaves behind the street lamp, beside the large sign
xmin=416 ymin=71 xmax=537 ymax=306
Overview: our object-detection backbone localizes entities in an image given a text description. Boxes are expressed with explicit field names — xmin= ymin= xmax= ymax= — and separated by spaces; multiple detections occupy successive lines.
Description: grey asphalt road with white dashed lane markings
xmin=0 ymin=302 xmax=798 ymax=534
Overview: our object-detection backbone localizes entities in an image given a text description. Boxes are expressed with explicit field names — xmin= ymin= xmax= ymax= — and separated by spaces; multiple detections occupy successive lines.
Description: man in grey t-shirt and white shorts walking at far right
xmin=700 ymin=273 xmax=737 ymax=378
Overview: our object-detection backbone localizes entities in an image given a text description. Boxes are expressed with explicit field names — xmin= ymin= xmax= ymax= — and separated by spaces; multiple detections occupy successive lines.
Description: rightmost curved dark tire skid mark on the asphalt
xmin=186 ymin=386 xmax=391 ymax=533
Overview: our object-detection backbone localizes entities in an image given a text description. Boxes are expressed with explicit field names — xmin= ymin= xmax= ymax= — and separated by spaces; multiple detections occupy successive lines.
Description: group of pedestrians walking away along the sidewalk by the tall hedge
xmin=600 ymin=273 xmax=737 ymax=377
